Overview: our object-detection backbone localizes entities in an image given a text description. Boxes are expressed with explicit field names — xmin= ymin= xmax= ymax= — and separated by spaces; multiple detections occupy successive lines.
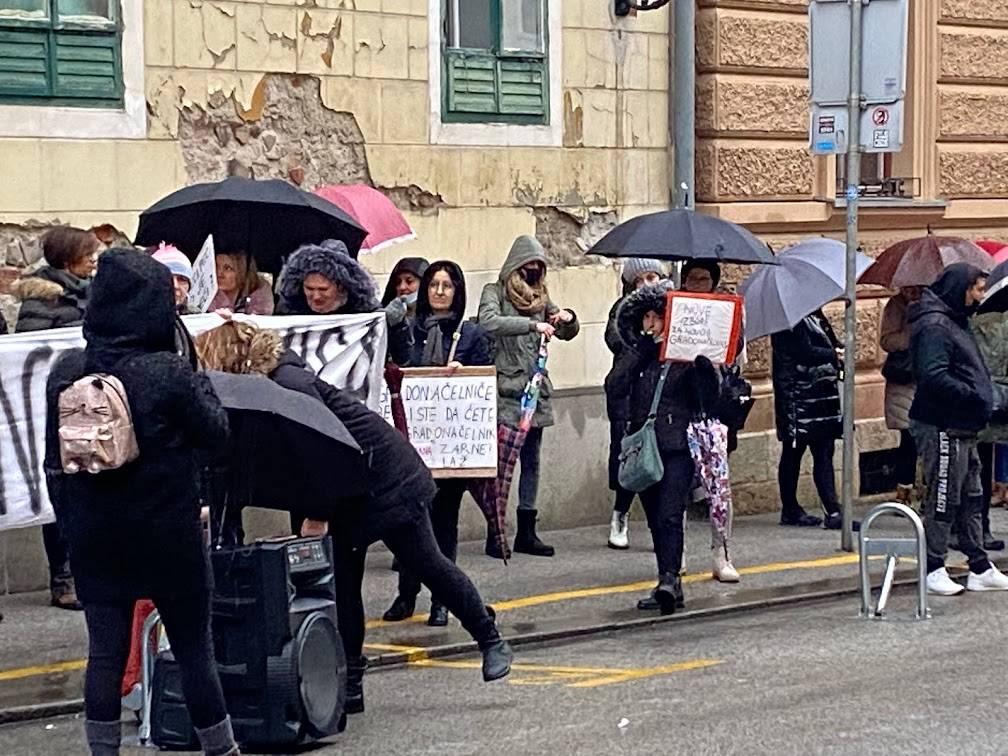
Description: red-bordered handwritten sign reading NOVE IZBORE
xmin=661 ymin=291 xmax=742 ymax=365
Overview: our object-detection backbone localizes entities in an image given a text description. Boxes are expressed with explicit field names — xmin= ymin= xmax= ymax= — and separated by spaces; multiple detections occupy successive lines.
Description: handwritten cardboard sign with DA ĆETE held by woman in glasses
xmin=381 ymin=367 xmax=497 ymax=478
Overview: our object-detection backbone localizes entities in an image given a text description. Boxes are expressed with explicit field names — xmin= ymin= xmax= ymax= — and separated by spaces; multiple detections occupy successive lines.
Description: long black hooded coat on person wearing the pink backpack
xmin=45 ymin=249 xmax=228 ymax=603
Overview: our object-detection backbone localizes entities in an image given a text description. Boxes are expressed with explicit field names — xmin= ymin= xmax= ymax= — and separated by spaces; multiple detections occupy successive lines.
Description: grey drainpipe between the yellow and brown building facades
xmin=672 ymin=0 xmax=697 ymax=210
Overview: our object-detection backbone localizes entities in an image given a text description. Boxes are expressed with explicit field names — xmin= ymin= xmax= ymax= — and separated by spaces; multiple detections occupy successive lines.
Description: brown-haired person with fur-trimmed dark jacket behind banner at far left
xmin=10 ymin=226 xmax=99 ymax=610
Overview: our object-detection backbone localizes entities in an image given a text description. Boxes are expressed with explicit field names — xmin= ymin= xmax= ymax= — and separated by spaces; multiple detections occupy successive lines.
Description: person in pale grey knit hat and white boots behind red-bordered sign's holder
xmin=606 ymin=257 xmax=667 ymax=549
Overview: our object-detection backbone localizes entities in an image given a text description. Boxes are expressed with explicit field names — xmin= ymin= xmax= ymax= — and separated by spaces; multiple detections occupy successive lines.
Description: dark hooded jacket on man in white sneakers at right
xmin=907 ymin=263 xmax=994 ymax=432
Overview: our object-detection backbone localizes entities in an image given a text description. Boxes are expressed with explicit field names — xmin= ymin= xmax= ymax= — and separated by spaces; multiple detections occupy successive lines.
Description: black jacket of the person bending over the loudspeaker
xmin=269 ymin=352 xmax=437 ymax=545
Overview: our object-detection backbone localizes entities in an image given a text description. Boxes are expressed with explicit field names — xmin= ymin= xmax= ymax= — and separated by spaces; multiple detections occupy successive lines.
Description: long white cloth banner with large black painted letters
xmin=0 ymin=312 xmax=388 ymax=530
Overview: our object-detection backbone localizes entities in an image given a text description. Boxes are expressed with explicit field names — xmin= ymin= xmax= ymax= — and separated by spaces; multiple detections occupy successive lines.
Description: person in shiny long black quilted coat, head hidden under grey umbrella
xmin=770 ymin=309 xmax=843 ymax=530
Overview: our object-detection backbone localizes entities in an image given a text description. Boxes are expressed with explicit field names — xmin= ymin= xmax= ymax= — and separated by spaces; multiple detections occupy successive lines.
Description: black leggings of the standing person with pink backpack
xmin=84 ymin=595 xmax=228 ymax=730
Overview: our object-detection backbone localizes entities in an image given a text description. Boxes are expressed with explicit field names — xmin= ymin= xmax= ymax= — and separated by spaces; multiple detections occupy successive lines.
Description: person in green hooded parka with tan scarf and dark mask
xmin=479 ymin=236 xmax=581 ymax=556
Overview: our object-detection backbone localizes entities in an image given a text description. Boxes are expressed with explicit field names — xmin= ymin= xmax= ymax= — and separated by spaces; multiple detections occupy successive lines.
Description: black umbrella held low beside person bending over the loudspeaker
xmin=207 ymin=371 xmax=367 ymax=520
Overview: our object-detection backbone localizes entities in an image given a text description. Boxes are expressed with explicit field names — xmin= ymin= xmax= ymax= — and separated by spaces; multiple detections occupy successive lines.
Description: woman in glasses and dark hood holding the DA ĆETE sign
xmin=383 ymin=260 xmax=493 ymax=627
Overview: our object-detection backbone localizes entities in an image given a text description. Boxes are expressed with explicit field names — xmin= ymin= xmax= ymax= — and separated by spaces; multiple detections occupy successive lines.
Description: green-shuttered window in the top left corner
xmin=0 ymin=0 xmax=124 ymax=108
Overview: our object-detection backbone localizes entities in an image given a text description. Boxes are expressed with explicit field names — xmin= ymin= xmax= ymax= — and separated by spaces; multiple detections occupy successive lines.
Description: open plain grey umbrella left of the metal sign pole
xmin=739 ymin=239 xmax=872 ymax=340
